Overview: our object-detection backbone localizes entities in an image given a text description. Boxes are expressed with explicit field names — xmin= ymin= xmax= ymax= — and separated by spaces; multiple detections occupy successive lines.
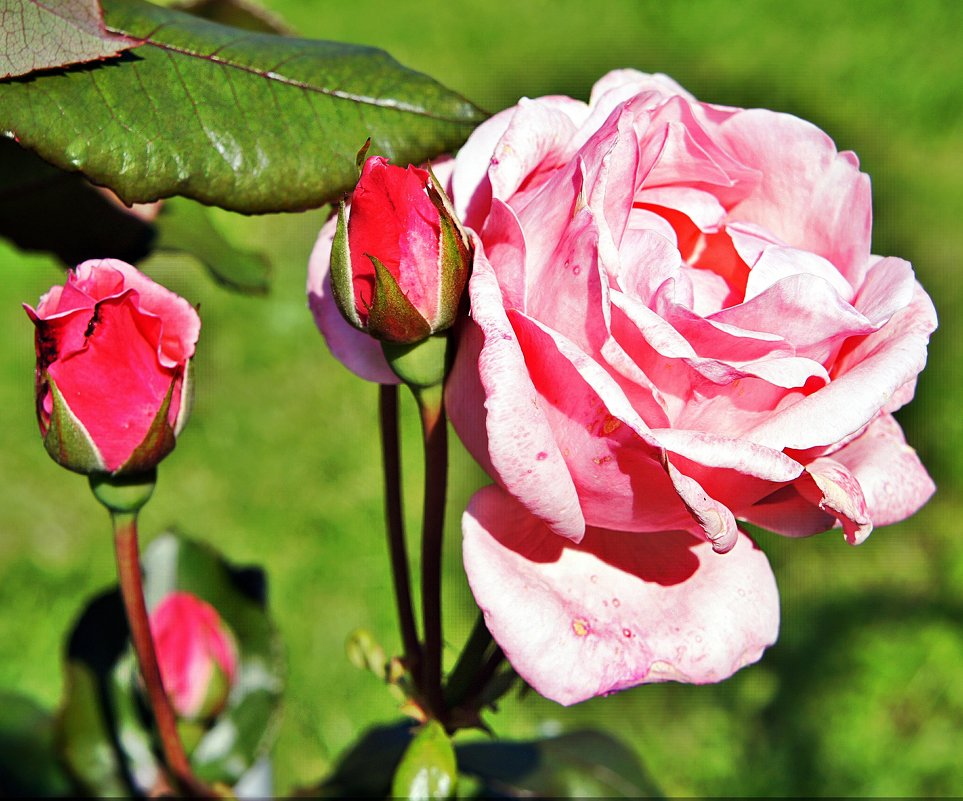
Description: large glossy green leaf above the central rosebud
xmin=0 ymin=0 xmax=484 ymax=212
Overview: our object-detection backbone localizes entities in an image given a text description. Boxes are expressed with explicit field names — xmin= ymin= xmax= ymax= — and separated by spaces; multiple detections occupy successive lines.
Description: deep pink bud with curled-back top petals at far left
xmin=24 ymin=259 xmax=201 ymax=475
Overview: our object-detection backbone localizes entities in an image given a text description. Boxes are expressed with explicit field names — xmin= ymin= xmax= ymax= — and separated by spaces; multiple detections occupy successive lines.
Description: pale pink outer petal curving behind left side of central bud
xmin=308 ymin=211 xmax=400 ymax=384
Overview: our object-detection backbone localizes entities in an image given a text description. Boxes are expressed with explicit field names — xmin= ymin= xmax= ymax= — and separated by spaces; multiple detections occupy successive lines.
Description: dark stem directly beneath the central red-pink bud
xmin=415 ymin=384 xmax=448 ymax=723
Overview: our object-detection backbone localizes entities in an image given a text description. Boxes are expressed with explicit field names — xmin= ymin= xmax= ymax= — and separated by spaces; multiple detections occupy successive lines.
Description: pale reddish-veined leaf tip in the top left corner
xmin=0 ymin=0 xmax=138 ymax=78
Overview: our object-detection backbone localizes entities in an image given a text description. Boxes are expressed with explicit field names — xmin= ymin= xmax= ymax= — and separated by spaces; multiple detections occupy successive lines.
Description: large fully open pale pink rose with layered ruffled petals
xmin=447 ymin=71 xmax=936 ymax=704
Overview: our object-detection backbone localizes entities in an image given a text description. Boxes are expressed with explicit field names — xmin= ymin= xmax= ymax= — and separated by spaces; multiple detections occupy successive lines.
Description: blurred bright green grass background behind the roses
xmin=0 ymin=0 xmax=963 ymax=796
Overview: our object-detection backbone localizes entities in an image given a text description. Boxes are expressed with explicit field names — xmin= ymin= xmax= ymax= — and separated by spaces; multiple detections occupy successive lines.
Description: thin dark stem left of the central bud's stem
xmin=378 ymin=384 xmax=421 ymax=676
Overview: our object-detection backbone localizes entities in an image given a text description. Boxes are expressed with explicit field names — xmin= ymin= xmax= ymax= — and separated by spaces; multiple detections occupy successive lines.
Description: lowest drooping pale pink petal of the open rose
xmin=462 ymin=487 xmax=779 ymax=705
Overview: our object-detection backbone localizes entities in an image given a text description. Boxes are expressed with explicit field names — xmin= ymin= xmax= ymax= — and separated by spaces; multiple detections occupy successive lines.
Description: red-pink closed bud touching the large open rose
xmin=331 ymin=156 xmax=470 ymax=344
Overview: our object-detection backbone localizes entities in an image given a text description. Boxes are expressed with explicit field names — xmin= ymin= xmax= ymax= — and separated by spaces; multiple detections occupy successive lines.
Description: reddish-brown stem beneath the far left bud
xmin=111 ymin=512 xmax=217 ymax=798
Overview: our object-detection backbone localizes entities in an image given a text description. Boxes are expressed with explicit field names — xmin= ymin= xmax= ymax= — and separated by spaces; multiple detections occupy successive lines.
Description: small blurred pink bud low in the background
xmin=150 ymin=592 xmax=238 ymax=720
